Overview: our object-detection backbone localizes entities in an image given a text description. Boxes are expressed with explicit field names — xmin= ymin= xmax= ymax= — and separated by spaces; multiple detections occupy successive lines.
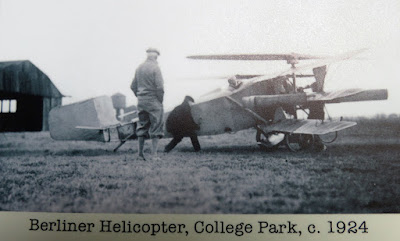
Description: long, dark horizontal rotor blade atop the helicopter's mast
xmin=187 ymin=53 xmax=329 ymax=61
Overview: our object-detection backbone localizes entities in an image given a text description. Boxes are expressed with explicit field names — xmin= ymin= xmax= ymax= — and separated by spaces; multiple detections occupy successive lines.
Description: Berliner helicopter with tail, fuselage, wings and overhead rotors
xmin=49 ymin=49 xmax=388 ymax=152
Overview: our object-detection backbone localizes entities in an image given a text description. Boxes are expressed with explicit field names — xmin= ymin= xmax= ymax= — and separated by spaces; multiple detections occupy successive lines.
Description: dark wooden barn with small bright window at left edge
xmin=0 ymin=60 xmax=63 ymax=132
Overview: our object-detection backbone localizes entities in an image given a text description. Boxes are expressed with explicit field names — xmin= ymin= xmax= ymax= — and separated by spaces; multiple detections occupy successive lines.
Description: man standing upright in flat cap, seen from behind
xmin=131 ymin=48 xmax=164 ymax=161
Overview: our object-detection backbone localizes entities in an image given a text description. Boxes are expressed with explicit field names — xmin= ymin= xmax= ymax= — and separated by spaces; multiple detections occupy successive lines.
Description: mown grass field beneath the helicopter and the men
xmin=0 ymin=118 xmax=400 ymax=213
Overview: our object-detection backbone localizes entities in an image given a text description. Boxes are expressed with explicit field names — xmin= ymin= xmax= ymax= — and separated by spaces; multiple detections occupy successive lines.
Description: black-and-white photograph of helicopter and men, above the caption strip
xmin=0 ymin=0 xmax=400 ymax=214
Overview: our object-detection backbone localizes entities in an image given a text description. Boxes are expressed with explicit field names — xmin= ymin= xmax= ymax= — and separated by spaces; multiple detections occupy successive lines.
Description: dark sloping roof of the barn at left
xmin=0 ymin=60 xmax=64 ymax=98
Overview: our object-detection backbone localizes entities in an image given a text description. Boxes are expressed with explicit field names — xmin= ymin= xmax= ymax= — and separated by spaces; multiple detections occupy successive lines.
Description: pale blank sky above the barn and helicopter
xmin=0 ymin=0 xmax=400 ymax=116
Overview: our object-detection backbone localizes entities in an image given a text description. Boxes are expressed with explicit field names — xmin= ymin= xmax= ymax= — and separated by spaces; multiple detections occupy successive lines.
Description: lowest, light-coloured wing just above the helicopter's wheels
xmin=263 ymin=119 xmax=357 ymax=135
